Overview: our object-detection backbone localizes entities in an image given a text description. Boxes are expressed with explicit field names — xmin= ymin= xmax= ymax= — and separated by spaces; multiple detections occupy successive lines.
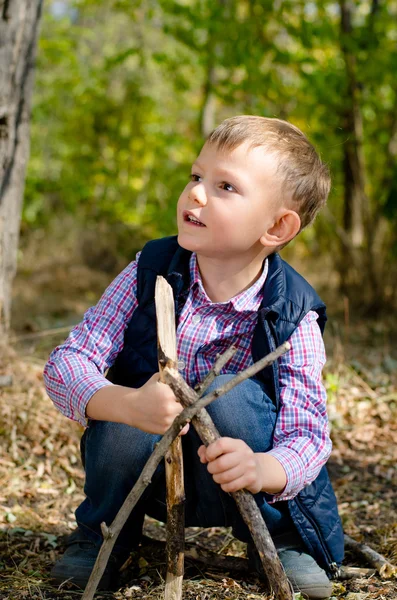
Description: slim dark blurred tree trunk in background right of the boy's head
xmin=338 ymin=0 xmax=384 ymax=310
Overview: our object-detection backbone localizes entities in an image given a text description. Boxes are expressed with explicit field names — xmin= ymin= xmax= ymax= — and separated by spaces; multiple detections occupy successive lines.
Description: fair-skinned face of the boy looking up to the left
xmin=177 ymin=143 xmax=282 ymax=260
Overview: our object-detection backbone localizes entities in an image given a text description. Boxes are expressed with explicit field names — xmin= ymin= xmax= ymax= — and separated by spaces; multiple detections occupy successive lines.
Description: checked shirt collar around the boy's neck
xmin=189 ymin=252 xmax=268 ymax=312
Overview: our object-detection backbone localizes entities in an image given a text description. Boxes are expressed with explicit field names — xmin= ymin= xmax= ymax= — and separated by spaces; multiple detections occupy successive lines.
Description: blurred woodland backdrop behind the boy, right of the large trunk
xmin=12 ymin=0 xmax=397 ymax=350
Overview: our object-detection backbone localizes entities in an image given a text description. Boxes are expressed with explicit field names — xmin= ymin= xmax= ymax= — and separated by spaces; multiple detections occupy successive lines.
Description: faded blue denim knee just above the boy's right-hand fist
xmin=207 ymin=374 xmax=277 ymax=452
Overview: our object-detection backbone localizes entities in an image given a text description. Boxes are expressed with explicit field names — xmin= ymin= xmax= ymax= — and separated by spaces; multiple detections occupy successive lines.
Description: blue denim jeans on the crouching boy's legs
xmin=76 ymin=375 xmax=294 ymax=549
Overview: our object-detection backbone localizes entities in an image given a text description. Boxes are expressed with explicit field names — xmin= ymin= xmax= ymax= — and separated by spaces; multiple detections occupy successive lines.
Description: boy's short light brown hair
xmin=207 ymin=115 xmax=331 ymax=230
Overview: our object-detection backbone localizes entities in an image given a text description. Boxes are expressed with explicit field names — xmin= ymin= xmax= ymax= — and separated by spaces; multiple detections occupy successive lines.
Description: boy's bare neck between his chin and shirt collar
xmin=197 ymin=254 xmax=267 ymax=302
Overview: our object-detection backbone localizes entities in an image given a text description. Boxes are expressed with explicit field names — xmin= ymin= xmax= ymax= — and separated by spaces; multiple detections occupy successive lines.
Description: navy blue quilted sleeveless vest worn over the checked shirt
xmin=109 ymin=237 xmax=344 ymax=575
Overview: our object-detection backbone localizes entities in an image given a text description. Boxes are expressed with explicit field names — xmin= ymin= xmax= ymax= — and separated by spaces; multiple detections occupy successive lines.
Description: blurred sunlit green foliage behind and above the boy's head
xmin=23 ymin=0 xmax=397 ymax=308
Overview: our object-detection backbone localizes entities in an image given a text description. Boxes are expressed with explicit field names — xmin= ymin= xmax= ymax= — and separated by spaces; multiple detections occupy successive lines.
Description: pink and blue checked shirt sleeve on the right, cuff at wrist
xmin=269 ymin=311 xmax=332 ymax=501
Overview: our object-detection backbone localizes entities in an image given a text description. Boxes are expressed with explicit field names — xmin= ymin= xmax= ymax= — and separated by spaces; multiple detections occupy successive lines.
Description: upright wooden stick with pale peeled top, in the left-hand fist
xmin=155 ymin=276 xmax=185 ymax=600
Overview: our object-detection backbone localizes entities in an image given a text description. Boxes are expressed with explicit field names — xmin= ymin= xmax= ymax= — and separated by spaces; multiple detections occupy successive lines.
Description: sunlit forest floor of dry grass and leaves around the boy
xmin=0 ymin=256 xmax=397 ymax=600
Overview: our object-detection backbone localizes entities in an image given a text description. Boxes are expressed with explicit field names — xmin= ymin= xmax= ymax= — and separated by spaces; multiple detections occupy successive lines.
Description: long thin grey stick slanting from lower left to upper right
xmin=82 ymin=342 xmax=292 ymax=600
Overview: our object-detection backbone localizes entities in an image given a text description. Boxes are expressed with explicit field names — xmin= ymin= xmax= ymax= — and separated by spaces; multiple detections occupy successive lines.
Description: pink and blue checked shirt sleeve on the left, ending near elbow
xmin=44 ymin=253 xmax=140 ymax=426
